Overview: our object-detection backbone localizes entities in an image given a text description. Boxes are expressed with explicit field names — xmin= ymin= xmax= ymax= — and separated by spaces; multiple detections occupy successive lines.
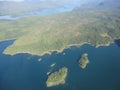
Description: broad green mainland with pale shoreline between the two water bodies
xmin=0 ymin=0 xmax=120 ymax=56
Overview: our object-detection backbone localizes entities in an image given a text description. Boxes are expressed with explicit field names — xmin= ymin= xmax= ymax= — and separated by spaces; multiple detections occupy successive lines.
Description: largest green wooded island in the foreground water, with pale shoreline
xmin=46 ymin=67 xmax=68 ymax=87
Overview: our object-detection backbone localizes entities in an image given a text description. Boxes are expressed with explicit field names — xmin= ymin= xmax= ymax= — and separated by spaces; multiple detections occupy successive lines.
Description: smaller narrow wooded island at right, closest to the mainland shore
xmin=79 ymin=53 xmax=90 ymax=69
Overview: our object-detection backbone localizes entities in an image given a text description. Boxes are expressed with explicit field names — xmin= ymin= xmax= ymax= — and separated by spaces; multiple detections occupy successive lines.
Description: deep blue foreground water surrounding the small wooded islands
xmin=0 ymin=41 xmax=120 ymax=90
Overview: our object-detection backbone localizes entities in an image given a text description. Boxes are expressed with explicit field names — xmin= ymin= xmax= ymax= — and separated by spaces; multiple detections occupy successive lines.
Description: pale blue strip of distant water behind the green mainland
xmin=0 ymin=4 xmax=80 ymax=20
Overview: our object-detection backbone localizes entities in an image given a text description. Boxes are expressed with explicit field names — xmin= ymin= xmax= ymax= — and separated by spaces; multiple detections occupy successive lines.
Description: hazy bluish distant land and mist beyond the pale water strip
xmin=0 ymin=0 xmax=120 ymax=15
